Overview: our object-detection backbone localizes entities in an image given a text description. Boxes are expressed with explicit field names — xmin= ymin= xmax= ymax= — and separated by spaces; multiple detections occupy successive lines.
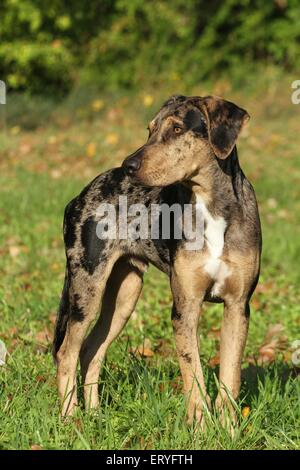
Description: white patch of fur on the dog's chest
xmin=196 ymin=196 xmax=229 ymax=295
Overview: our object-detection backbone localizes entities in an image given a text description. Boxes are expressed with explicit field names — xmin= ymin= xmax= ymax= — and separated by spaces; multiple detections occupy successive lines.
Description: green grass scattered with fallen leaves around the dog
xmin=0 ymin=71 xmax=300 ymax=449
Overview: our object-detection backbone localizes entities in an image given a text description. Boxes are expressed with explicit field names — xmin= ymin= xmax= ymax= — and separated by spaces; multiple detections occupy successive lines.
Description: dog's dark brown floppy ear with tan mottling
xmin=199 ymin=96 xmax=250 ymax=159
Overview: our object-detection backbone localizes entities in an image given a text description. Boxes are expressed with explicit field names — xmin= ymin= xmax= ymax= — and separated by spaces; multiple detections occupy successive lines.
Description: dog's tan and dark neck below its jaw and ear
xmin=185 ymin=147 xmax=245 ymax=213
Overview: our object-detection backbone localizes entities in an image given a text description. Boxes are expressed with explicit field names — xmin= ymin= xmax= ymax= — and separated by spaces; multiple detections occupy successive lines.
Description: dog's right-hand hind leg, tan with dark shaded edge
xmin=80 ymin=258 xmax=145 ymax=409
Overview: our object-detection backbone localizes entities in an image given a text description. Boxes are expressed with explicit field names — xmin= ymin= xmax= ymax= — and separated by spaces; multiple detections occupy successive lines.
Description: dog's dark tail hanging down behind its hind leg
xmin=52 ymin=271 xmax=70 ymax=362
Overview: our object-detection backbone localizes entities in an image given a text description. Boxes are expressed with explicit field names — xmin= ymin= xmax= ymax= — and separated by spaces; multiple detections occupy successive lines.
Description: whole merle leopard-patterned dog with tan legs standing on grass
xmin=53 ymin=96 xmax=261 ymax=422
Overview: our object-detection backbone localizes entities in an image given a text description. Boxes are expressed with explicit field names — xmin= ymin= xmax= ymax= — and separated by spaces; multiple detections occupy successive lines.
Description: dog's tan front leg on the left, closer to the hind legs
xmin=171 ymin=258 xmax=210 ymax=426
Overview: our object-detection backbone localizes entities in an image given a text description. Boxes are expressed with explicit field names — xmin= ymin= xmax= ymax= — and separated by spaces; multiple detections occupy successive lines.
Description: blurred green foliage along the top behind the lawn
xmin=0 ymin=0 xmax=300 ymax=94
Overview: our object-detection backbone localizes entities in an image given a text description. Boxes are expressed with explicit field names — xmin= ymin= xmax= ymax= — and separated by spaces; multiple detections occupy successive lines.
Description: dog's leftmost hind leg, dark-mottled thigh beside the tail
xmin=53 ymin=253 xmax=119 ymax=416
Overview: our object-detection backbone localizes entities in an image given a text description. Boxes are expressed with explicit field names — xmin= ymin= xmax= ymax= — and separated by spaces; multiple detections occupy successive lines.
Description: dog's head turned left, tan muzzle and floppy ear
xmin=123 ymin=95 xmax=249 ymax=186
